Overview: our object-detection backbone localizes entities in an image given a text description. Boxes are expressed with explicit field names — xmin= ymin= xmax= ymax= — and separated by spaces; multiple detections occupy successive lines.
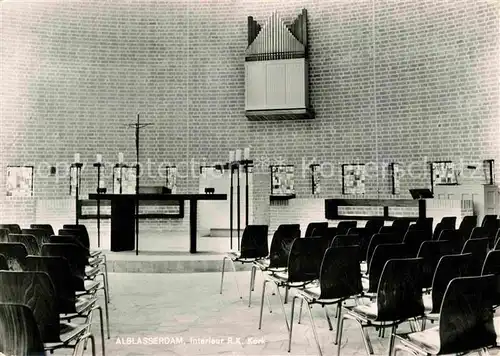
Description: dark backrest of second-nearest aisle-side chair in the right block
xmin=377 ymin=258 xmax=424 ymax=321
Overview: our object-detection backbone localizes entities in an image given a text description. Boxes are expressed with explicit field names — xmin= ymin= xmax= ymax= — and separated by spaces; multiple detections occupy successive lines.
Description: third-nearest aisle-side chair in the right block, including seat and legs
xmin=288 ymin=246 xmax=363 ymax=355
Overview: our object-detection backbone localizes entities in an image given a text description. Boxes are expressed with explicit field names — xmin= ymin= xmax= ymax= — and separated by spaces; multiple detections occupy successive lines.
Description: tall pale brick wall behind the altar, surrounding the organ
xmin=0 ymin=0 xmax=500 ymax=232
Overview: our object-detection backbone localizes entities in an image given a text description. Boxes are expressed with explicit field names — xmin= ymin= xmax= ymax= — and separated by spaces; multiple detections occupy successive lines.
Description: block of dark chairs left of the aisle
xmin=0 ymin=224 xmax=110 ymax=355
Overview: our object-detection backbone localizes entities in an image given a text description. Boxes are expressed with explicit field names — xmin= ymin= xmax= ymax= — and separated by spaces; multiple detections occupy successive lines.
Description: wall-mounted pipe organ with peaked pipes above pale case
xmin=245 ymin=9 xmax=314 ymax=120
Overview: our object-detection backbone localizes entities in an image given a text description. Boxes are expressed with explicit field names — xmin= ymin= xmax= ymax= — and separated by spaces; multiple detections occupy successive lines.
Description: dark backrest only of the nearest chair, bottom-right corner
xmin=439 ymin=275 xmax=497 ymax=355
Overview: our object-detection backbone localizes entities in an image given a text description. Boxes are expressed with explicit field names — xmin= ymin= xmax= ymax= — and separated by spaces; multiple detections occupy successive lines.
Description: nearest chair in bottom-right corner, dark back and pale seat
xmin=394 ymin=275 xmax=497 ymax=355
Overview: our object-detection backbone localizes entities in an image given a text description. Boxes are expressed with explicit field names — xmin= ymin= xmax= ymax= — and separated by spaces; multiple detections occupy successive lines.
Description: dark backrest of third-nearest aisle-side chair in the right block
xmin=319 ymin=246 xmax=363 ymax=299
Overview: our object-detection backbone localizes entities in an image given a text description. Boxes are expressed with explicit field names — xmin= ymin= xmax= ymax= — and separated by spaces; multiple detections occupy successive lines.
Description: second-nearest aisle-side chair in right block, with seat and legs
xmin=337 ymin=258 xmax=424 ymax=355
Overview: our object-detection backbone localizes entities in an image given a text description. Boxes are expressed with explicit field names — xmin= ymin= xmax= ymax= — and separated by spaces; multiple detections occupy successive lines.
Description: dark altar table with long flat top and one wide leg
xmin=89 ymin=194 xmax=227 ymax=253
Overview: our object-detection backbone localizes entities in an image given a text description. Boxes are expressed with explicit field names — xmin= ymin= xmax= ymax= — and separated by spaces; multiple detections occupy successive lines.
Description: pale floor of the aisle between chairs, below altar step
xmin=73 ymin=272 xmax=434 ymax=356
